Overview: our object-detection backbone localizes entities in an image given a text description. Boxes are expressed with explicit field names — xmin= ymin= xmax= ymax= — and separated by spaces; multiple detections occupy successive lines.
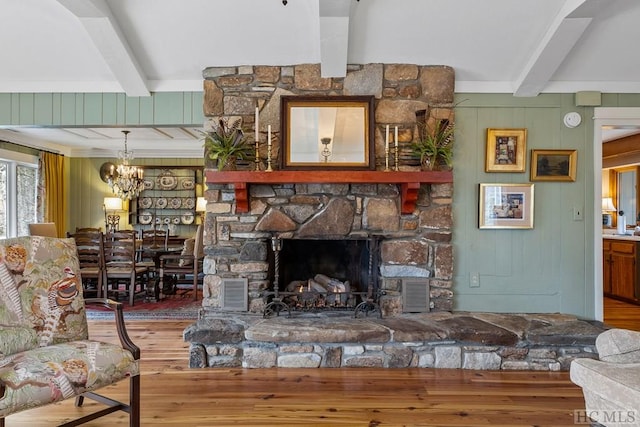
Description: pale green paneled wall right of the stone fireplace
xmin=453 ymin=93 xmax=640 ymax=318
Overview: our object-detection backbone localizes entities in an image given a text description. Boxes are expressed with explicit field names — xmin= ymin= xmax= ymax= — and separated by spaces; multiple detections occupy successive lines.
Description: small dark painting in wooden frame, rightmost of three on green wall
xmin=531 ymin=150 xmax=578 ymax=181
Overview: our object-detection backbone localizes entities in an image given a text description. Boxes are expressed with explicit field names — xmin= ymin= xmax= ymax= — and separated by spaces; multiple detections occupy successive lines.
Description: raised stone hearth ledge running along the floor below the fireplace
xmin=184 ymin=310 xmax=606 ymax=371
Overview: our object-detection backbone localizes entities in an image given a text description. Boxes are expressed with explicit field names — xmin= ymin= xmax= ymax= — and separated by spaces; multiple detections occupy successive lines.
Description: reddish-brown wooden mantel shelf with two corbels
xmin=205 ymin=169 xmax=453 ymax=214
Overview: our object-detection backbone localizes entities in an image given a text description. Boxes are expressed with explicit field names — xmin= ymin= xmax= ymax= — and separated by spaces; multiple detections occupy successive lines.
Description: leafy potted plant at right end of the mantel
xmin=411 ymin=119 xmax=453 ymax=170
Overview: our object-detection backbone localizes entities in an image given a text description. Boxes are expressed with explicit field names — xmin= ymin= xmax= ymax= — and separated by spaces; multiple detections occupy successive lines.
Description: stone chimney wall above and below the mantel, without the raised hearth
xmin=203 ymin=64 xmax=455 ymax=316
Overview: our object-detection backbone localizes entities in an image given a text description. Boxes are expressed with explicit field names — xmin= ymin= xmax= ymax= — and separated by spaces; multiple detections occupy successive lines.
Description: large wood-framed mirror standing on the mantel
xmin=280 ymin=96 xmax=375 ymax=170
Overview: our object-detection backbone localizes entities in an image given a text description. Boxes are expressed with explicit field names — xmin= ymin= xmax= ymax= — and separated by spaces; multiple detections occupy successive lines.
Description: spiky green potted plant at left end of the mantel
xmin=204 ymin=118 xmax=253 ymax=170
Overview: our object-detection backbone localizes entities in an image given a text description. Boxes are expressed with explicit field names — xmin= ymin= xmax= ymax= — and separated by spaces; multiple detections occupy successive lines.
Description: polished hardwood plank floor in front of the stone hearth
xmin=7 ymin=320 xmax=584 ymax=427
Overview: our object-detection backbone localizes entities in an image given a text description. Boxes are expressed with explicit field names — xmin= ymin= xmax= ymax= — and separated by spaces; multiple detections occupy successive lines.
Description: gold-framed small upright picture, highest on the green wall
xmin=484 ymin=128 xmax=527 ymax=172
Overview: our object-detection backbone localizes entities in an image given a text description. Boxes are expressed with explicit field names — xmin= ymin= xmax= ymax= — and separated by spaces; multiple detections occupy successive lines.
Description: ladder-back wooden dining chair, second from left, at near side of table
xmin=103 ymin=230 xmax=149 ymax=305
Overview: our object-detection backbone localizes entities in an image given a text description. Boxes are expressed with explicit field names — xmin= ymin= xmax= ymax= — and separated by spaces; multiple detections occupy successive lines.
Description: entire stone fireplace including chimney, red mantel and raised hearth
xmin=184 ymin=64 xmax=602 ymax=370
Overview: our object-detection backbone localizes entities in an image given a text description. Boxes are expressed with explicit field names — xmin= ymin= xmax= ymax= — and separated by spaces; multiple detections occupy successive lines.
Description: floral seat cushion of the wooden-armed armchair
xmin=0 ymin=340 xmax=139 ymax=417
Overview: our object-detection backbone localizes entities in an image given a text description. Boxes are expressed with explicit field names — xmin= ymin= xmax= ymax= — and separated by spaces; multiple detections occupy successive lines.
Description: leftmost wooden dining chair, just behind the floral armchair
xmin=67 ymin=231 xmax=106 ymax=298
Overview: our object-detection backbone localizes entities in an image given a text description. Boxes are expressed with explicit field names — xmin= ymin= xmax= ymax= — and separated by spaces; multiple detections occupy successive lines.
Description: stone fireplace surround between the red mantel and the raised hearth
xmin=203 ymin=179 xmax=453 ymax=316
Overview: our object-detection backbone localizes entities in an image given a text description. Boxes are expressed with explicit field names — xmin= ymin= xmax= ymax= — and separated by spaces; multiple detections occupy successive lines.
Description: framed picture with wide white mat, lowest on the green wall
xmin=478 ymin=184 xmax=534 ymax=228
